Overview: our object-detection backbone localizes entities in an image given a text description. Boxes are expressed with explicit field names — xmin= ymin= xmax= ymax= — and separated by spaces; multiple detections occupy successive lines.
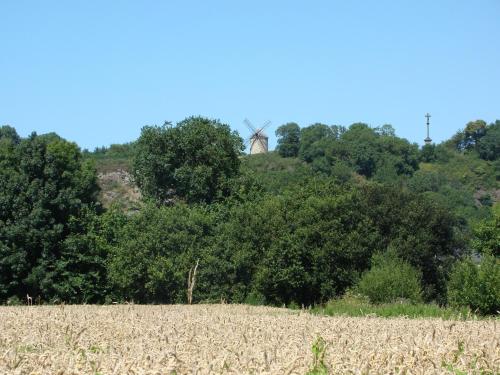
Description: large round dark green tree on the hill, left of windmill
xmin=133 ymin=117 xmax=243 ymax=203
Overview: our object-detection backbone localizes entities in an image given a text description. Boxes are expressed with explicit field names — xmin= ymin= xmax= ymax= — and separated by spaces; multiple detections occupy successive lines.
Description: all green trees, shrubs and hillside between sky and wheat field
xmin=0 ymin=117 xmax=500 ymax=315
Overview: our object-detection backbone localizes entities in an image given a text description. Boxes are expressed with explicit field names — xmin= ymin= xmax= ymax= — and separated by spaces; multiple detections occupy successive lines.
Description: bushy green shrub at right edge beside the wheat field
xmin=448 ymin=255 xmax=500 ymax=314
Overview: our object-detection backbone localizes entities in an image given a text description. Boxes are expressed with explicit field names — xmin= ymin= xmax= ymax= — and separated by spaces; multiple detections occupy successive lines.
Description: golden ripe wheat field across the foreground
xmin=0 ymin=305 xmax=500 ymax=374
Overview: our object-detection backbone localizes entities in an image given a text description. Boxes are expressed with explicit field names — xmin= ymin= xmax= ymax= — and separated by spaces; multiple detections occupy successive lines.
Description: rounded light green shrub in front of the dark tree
xmin=355 ymin=251 xmax=422 ymax=303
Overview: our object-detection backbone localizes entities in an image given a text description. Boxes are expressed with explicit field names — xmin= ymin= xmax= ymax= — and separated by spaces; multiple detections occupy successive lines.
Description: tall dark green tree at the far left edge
xmin=0 ymin=132 xmax=101 ymax=300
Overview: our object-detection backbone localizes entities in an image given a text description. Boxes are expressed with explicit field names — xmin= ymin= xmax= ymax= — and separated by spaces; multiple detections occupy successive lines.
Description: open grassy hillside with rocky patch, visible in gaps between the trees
xmin=86 ymin=141 xmax=500 ymax=220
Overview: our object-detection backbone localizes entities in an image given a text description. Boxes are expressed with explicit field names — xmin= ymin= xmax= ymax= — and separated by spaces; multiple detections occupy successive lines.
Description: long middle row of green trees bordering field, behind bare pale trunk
xmin=100 ymin=179 xmax=453 ymax=304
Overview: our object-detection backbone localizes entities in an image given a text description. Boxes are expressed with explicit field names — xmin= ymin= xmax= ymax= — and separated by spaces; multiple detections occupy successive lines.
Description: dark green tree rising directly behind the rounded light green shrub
xmin=359 ymin=183 xmax=463 ymax=302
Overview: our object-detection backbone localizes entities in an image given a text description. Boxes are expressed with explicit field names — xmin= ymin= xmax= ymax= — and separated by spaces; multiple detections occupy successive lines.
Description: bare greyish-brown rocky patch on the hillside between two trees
xmin=97 ymin=169 xmax=141 ymax=209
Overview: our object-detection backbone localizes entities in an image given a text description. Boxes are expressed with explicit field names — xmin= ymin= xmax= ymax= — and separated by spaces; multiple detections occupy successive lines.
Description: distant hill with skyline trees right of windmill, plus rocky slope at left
xmin=84 ymin=121 xmax=500 ymax=226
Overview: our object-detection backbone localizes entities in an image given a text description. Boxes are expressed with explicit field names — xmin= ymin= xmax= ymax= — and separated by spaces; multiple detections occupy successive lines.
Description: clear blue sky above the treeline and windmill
xmin=0 ymin=0 xmax=500 ymax=149
